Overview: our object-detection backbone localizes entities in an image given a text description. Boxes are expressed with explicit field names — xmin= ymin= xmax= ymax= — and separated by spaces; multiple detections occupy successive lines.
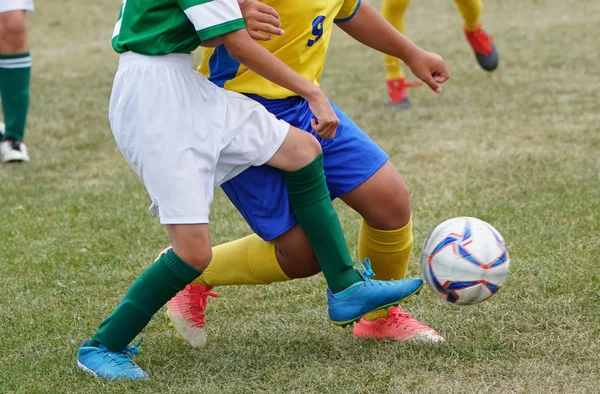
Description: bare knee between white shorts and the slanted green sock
xmin=165 ymin=224 xmax=212 ymax=270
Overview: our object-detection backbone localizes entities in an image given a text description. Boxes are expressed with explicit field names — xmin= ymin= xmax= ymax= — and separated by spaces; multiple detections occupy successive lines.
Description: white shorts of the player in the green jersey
xmin=108 ymin=52 xmax=290 ymax=224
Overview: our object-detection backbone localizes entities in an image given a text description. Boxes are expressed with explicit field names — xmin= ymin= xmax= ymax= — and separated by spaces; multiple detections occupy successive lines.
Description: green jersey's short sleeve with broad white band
xmin=176 ymin=0 xmax=246 ymax=41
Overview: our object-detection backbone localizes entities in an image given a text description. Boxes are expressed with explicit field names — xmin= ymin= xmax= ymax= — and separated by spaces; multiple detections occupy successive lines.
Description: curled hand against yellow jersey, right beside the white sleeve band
xmin=238 ymin=0 xmax=283 ymax=41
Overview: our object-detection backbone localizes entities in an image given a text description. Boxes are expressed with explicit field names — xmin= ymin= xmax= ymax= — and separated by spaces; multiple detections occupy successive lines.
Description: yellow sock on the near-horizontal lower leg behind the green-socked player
xmin=194 ymin=234 xmax=290 ymax=286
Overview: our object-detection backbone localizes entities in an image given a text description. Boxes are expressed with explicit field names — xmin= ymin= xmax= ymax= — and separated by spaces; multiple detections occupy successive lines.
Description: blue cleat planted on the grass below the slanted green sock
xmin=77 ymin=339 xmax=148 ymax=380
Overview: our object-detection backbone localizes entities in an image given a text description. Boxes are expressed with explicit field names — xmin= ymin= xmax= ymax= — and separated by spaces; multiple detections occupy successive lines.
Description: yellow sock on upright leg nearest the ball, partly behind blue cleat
xmin=358 ymin=219 xmax=413 ymax=320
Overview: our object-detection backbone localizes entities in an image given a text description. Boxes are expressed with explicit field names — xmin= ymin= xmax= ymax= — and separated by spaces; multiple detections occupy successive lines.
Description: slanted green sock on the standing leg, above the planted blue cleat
xmin=88 ymin=249 xmax=201 ymax=351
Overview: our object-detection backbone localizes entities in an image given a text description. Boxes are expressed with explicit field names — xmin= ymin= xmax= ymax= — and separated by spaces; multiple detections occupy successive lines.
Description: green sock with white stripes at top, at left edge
xmin=0 ymin=52 xmax=31 ymax=141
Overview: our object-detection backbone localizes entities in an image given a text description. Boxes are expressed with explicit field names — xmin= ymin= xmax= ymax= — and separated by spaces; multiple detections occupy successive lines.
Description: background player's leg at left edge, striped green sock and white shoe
xmin=0 ymin=10 xmax=31 ymax=162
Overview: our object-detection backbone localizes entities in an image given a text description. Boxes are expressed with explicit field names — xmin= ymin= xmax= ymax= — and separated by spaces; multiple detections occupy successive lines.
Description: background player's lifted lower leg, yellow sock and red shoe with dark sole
xmin=454 ymin=0 xmax=499 ymax=71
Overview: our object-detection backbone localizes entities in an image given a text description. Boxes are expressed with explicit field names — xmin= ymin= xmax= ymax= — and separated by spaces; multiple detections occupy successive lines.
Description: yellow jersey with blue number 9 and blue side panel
xmin=198 ymin=0 xmax=360 ymax=99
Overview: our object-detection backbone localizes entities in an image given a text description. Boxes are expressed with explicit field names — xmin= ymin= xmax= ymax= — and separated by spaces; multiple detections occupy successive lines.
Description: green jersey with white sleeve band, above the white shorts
xmin=112 ymin=0 xmax=246 ymax=55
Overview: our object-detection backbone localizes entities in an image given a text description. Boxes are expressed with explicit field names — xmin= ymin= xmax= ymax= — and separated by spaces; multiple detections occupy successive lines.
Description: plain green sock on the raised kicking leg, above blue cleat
xmin=285 ymin=154 xmax=362 ymax=293
